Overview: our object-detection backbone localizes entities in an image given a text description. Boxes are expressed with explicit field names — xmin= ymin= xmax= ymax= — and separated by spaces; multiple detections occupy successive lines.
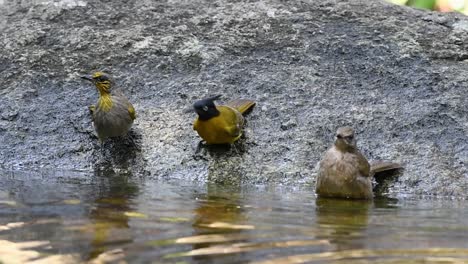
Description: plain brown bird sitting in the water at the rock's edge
xmin=315 ymin=127 xmax=402 ymax=200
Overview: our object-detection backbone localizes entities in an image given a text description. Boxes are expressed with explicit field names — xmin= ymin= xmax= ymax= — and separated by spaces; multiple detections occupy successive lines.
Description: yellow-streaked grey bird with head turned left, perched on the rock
xmin=81 ymin=72 xmax=136 ymax=142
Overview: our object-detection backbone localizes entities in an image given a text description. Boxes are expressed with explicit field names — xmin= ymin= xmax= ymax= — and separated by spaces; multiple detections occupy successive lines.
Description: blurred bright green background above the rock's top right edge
xmin=388 ymin=0 xmax=468 ymax=15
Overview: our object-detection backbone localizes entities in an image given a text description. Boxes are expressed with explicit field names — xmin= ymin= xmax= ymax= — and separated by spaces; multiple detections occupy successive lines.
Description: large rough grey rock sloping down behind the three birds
xmin=0 ymin=0 xmax=468 ymax=196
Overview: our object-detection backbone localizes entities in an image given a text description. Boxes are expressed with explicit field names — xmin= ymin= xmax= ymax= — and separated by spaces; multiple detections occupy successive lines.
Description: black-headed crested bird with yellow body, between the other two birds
xmin=193 ymin=95 xmax=255 ymax=145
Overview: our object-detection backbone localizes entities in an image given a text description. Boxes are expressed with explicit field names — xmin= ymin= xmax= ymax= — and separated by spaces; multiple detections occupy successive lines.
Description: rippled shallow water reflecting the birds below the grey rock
xmin=0 ymin=168 xmax=468 ymax=263
